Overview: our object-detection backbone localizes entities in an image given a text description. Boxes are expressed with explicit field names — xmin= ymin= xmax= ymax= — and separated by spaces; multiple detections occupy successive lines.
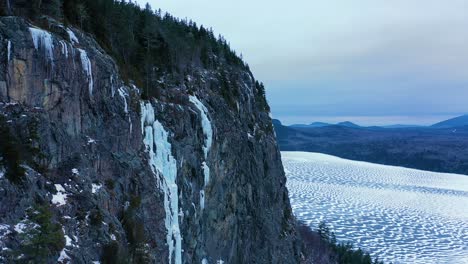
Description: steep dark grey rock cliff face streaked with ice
xmin=0 ymin=17 xmax=299 ymax=263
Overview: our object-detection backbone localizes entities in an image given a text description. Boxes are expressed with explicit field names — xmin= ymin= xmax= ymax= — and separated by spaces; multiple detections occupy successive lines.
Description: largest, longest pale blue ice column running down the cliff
xmin=140 ymin=102 xmax=182 ymax=264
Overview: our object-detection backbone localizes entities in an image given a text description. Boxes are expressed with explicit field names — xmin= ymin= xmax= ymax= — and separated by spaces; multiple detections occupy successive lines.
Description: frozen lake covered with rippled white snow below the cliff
xmin=281 ymin=152 xmax=468 ymax=263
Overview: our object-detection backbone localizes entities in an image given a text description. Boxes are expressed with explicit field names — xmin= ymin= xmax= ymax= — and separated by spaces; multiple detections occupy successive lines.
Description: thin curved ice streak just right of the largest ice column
xmin=189 ymin=96 xmax=213 ymax=209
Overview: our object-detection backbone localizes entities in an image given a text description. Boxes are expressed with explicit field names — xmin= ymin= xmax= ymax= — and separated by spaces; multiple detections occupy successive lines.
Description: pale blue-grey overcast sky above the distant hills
xmin=139 ymin=0 xmax=468 ymax=125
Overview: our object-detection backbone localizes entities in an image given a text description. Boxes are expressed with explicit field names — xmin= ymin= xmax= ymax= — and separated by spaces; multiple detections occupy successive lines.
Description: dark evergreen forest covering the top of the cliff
xmin=0 ymin=0 xmax=267 ymax=104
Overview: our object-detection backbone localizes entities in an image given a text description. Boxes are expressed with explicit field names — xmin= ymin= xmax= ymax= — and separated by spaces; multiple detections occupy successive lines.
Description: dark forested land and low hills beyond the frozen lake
xmin=273 ymin=121 xmax=468 ymax=175
